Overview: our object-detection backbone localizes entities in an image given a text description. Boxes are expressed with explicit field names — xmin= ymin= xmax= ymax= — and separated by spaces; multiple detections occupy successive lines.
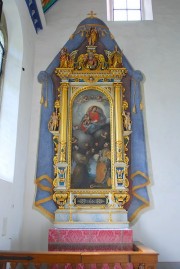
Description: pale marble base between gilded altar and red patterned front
xmin=54 ymin=208 xmax=129 ymax=227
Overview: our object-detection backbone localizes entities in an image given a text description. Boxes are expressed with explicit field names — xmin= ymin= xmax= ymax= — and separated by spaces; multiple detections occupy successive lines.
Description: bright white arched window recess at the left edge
xmin=0 ymin=3 xmax=23 ymax=182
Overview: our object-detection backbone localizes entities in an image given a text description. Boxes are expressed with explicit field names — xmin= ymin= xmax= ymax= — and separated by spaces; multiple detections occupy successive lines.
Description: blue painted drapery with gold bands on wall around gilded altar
xmin=35 ymin=15 xmax=149 ymax=221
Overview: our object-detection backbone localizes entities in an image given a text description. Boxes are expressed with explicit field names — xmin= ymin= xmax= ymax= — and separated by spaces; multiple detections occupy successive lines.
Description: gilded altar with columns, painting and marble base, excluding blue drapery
xmin=49 ymin=42 xmax=131 ymax=228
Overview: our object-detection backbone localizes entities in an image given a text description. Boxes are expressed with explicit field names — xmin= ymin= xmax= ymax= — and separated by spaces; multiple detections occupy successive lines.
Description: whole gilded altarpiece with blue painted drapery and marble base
xmin=35 ymin=13 xmax=149 ymax=228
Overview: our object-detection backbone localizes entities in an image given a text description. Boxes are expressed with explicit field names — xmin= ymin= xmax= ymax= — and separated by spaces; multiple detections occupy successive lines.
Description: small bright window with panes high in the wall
xmin=107 ymin=0 xmax=153 ymax=21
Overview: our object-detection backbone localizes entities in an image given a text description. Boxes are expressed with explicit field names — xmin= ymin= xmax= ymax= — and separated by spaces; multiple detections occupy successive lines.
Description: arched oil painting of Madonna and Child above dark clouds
xmin=71 ymin=90 xmax=112 ymax=189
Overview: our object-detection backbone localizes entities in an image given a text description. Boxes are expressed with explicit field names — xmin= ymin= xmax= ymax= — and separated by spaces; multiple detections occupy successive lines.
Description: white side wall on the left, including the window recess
xmin=0 ymin=0 xmax=35 ymax=249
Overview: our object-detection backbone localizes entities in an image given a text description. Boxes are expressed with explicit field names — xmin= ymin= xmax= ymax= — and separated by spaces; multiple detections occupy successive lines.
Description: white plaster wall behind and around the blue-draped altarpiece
xmin=1 ymin=0 xmax=180 ymax=261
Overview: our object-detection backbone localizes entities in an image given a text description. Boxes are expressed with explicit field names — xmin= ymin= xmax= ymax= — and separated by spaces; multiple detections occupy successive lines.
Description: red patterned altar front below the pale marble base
xmin=48 ymin=228 xmax=133 ymax=251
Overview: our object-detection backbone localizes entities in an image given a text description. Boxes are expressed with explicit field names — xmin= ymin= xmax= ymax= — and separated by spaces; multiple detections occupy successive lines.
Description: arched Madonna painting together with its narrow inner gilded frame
xmin=67 ymin=85 xmax=114 ymax=193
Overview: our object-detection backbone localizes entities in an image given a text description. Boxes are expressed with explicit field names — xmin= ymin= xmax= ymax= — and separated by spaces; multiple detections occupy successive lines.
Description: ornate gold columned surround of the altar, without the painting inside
xmin=49 ymin=42 xmax=131 ymax=209
